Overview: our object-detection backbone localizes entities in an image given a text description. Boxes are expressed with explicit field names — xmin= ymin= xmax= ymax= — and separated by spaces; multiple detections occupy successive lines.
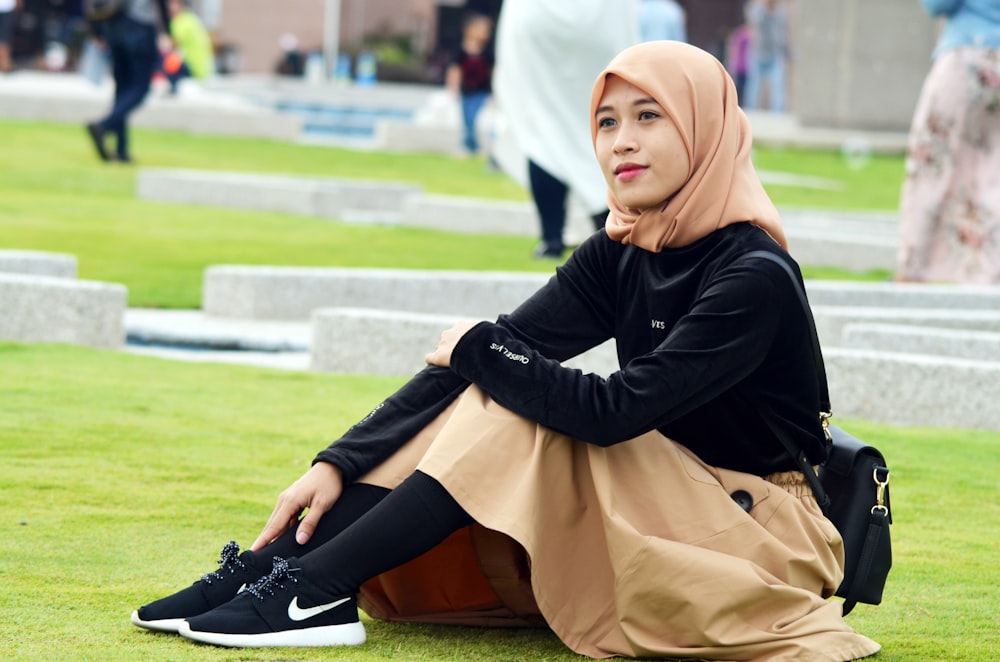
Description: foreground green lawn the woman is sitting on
xmin=0 ymin=343 xmax=1000 ymax=662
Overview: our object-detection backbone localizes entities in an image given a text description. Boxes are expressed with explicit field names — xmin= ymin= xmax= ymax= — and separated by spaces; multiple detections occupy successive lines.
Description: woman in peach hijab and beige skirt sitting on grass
xmin=132 ymin=42 xmax=879 ymax=660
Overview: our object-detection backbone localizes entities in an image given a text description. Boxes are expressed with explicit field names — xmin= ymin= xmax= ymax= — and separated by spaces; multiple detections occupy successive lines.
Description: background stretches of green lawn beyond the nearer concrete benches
xmin=0 ymin=120 xmax=902 ymax=308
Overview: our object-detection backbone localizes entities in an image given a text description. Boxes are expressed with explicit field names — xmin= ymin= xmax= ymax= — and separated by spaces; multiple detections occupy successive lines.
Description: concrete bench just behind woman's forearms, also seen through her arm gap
xmin=310 ymin=308 xmax=618 ymax=376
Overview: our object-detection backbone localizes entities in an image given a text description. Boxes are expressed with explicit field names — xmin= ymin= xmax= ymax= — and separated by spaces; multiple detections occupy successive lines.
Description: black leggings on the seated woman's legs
xmin=258 ymin=471 xmax=473 ymax=595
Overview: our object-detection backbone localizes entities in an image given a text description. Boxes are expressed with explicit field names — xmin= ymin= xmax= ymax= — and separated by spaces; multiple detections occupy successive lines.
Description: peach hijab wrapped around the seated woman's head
xmin=590 ymin=41 xmax=788 ymax=253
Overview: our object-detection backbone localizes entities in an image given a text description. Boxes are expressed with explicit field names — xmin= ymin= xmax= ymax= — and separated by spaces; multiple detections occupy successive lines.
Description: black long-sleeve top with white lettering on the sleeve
xmin=316 ymin=223 xmax=826 ymax=482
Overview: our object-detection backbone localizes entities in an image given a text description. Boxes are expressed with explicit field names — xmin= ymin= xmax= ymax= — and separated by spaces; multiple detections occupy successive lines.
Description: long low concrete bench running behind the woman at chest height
xmin=202 ymin=265 xmax=1000 ymax=326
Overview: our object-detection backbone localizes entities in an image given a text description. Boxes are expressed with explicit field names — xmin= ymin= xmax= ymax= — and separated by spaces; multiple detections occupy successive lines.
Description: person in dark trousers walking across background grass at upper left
xmin=86 ymin=0 xmax=170 ymax=163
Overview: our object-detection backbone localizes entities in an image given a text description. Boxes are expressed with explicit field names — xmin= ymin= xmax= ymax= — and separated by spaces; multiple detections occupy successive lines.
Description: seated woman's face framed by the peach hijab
xmin=594 ymin=75 xmax=691 ymax=211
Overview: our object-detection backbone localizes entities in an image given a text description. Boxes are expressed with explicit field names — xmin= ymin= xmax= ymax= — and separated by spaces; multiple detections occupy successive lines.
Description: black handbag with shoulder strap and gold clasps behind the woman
xmin=748 ymin=251 xmax=892 ymax=615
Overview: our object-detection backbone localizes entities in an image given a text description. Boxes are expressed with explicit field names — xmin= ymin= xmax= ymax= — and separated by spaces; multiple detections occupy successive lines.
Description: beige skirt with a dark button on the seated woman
xmin=361 ymin=386 xmax=879 ymax=661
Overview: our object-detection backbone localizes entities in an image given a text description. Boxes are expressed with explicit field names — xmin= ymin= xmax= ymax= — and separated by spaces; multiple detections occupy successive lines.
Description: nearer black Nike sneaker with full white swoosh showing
xmin=178 ymin=557 xmax=365 ymax=648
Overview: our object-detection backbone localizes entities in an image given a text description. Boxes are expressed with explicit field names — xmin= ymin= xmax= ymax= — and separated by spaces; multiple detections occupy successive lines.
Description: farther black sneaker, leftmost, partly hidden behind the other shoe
xmin=132 ymin=541 xmax=264 ymax=632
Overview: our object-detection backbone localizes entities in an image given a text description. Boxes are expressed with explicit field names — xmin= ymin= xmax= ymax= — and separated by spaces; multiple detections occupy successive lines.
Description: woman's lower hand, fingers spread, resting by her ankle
xmin=250 ymin=462 xmax=344 ymax=552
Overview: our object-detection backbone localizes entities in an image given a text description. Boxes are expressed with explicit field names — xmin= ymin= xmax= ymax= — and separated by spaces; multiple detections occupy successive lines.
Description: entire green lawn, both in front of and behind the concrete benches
xmin=0 ymin=121 xmax=988 ymax=662
